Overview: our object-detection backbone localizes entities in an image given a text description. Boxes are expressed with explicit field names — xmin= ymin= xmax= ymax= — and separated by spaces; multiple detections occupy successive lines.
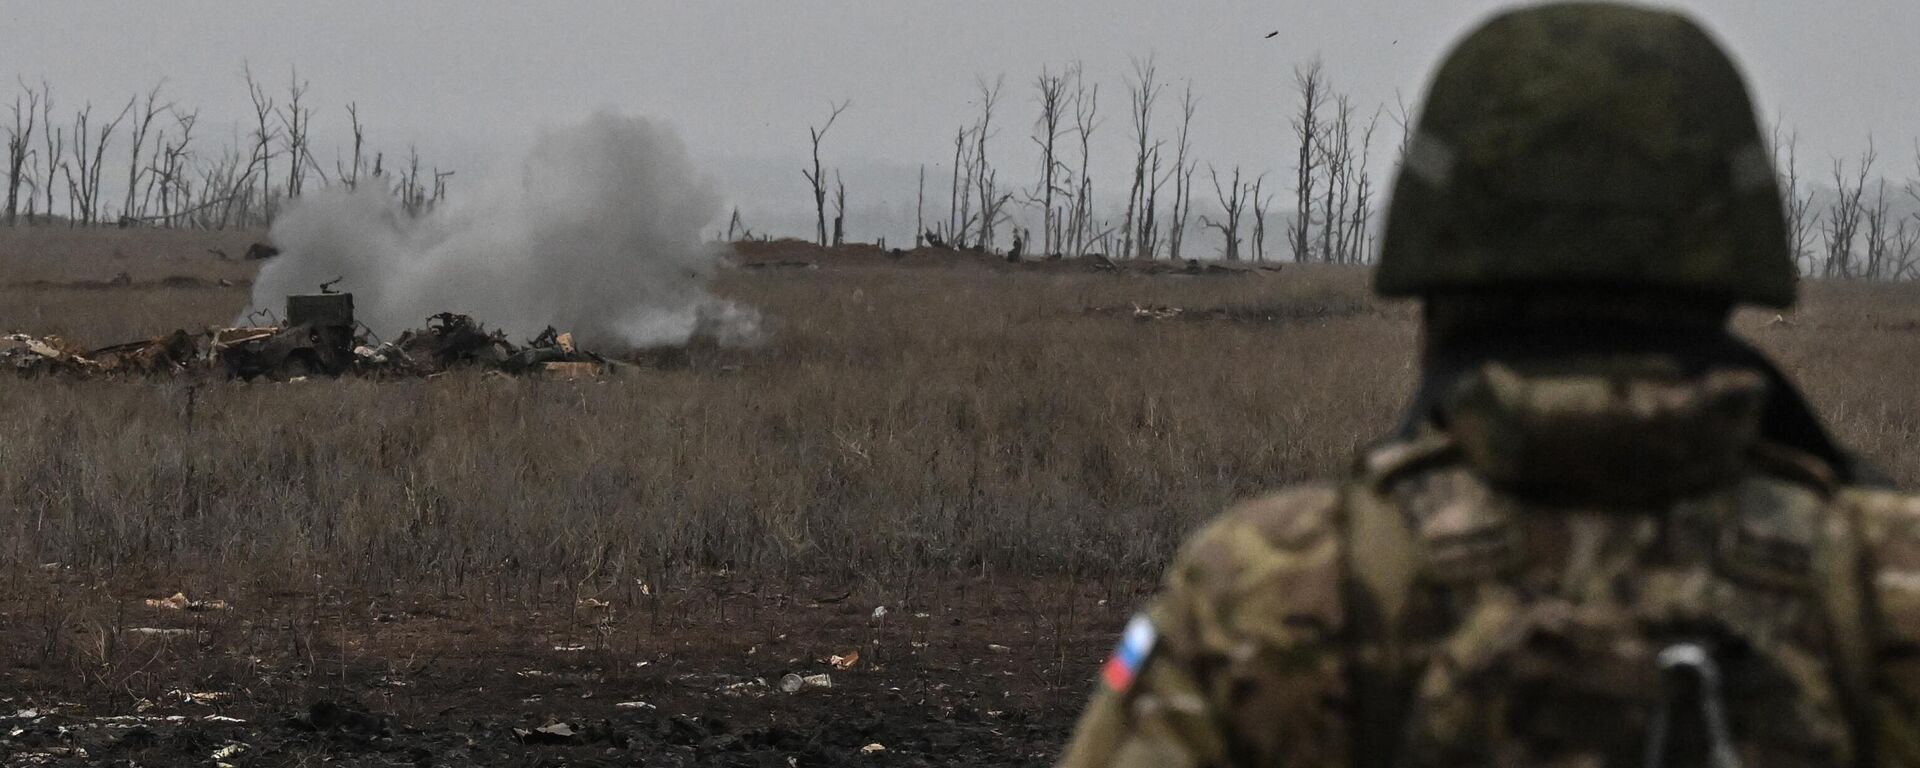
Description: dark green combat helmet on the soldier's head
xmin=1375 ymin=4 xmax=1797 ymax=307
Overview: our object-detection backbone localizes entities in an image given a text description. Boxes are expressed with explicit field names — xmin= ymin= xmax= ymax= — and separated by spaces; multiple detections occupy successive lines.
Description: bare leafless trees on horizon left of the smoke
xmin=0 ymin=69 xmax=453 ymax=228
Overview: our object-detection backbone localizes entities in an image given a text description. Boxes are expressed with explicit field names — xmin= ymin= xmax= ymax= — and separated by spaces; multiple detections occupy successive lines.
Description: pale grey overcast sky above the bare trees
xmin=0 ymin=0 xmax=1920 ymax=237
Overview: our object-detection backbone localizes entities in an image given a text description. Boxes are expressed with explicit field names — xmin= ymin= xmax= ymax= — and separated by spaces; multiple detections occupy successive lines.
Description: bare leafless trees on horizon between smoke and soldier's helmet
xmin=803 ymin=58 xmax=1404 ymax=263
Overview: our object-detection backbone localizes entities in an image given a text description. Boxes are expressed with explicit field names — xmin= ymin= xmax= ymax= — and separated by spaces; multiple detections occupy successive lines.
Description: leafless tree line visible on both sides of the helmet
xmin=802 ymin=58 xmax=1920 ymax=280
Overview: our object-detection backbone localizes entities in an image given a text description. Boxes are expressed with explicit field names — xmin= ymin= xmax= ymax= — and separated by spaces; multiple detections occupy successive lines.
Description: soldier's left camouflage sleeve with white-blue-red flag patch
xmin=1062 ymin=486 xmax=1348 ymax=768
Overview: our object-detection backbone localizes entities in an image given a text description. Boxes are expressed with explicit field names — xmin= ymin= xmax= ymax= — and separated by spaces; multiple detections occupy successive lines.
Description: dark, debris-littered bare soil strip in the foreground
xmin=0 ymin=580 xmax=1127 ymax=768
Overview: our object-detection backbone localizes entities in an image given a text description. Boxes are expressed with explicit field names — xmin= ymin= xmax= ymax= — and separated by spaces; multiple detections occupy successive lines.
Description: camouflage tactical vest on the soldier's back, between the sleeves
xmin=1342 ymin=367 xmax=1872 ymax=768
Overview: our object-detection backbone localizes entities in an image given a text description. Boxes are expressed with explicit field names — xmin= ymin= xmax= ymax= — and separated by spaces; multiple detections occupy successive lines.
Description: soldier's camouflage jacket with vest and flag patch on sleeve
xmin=1062 ymin=366 xmax=1920 ymax=768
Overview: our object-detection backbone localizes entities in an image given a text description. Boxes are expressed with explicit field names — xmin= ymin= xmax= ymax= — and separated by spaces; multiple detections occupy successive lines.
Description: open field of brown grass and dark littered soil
xmin=0 ymin=228 xmax=1920 ymax=766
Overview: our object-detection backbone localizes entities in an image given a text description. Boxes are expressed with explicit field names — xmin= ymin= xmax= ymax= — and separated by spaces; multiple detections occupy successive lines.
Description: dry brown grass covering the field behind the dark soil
xmin=0 ymin=226 xmax=1920 ymax=589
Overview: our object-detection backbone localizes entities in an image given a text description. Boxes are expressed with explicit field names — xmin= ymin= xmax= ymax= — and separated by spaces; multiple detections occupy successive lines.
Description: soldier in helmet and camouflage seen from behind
xmin=1064 ymin=4 xmax=1920 ymax=768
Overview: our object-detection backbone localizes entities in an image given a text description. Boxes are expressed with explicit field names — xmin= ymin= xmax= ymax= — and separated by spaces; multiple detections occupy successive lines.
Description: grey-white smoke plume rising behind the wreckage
xmin=248 ymin=111 xmax=758 ymax=349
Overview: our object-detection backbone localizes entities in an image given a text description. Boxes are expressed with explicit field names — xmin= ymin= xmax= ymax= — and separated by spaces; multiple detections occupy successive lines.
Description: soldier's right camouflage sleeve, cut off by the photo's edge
xmin=1859 ymin=493 xmax=1920 ymax=768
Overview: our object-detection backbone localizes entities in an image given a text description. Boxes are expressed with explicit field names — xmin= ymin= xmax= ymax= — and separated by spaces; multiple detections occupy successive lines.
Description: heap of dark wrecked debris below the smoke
xmin=0 ymin=294 xmax=620 ymax=380
